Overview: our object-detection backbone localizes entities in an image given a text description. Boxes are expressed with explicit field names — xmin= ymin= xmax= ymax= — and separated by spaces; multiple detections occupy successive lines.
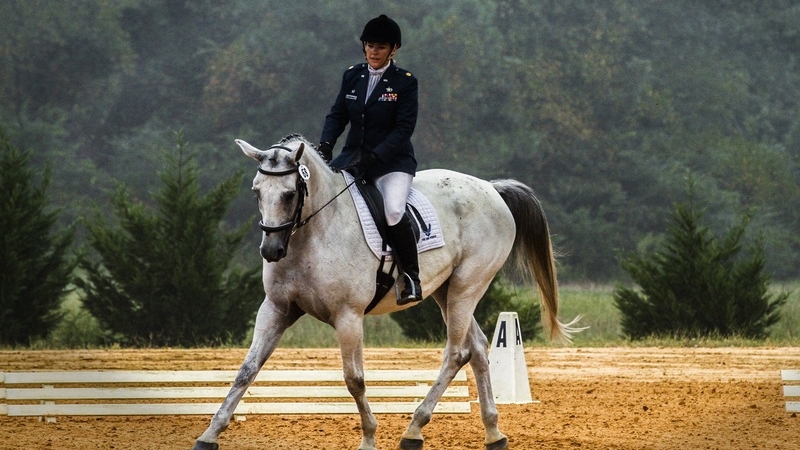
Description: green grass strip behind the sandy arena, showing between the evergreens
xmin=17 ymin=281 xmax=800 ymax=349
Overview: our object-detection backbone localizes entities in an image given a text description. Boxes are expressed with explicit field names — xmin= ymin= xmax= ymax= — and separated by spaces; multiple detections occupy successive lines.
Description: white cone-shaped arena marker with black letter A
xmin=489 ymin=312 xmax=533 ymax=403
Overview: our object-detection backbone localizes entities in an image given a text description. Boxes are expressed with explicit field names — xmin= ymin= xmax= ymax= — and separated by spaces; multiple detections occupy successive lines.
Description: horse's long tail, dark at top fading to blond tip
xmin=492 ymin=180 xmax=584 ymax=343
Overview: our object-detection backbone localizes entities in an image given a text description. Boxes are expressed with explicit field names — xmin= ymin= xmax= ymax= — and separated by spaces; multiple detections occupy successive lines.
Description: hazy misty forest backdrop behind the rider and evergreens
xmin=0 ymin=0 xmax=800 ymax=281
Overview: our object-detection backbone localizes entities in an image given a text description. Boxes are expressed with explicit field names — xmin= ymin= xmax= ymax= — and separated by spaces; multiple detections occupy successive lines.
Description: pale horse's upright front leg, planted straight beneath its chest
xmin=334 ymin=314 xmax=378 ymax=450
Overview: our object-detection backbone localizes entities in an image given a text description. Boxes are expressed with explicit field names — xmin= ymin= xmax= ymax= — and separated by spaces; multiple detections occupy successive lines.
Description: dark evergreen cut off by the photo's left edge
xmin=0 ymin=127 xmax=75 ymax=344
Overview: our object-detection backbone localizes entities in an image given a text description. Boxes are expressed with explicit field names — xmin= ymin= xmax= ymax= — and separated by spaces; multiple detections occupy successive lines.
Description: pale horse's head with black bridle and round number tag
xmin=236 ymin=139 xmax=310 ymax=262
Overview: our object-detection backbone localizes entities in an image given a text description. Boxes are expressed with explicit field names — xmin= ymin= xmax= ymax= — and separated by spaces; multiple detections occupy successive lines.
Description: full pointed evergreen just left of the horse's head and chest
xmin=78 ymin=134 xmax=263 ymax=346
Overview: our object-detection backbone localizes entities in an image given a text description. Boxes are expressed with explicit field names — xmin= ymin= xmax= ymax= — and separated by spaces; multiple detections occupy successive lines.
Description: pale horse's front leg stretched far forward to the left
xmin=192 ymin=298 xmax=302 ymax=450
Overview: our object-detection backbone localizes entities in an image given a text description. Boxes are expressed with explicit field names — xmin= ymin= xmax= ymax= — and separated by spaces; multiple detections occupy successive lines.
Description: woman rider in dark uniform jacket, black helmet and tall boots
xmin=319 ymin=14 xmax=423 ymax=305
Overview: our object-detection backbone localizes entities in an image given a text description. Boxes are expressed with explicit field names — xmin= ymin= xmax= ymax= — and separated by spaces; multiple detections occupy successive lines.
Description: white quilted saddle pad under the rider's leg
xmin=342 ymin=172 xmax=444 ymax=260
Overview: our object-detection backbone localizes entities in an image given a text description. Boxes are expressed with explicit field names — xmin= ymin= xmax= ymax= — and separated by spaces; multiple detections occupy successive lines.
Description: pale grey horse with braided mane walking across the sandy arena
xmin=193 ymin=135 xmax=581 ymax=450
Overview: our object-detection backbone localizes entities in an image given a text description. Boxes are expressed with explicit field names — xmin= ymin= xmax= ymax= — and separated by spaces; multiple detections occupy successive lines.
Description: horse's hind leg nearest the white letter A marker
xmin=467 ymin=317 xmax=508 ymax=450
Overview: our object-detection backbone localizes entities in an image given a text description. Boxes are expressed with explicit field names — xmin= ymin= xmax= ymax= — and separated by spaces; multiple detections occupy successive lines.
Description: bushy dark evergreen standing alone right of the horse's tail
xmin=614 ymin=181 xmax=788 ymax=339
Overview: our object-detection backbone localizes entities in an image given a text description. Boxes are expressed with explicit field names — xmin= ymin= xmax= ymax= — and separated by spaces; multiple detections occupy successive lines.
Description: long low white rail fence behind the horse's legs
xmin=0 ymin=370 xmax=470 ymax=421
